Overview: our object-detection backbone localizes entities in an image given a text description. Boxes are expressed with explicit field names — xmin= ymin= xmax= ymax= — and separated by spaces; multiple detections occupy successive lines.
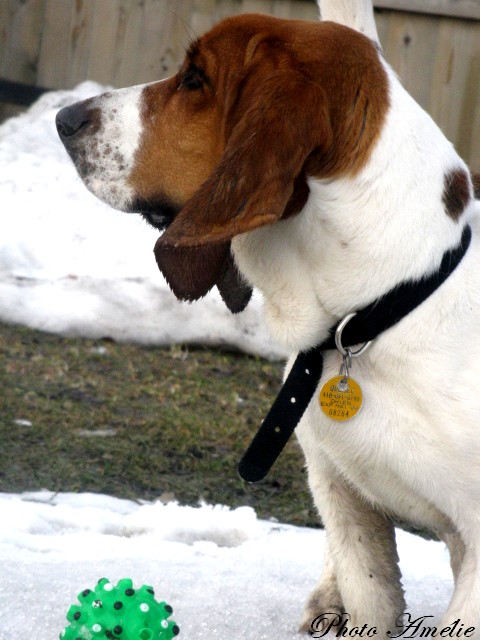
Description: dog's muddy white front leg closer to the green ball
xmin=300 ymin=444 xmax=405 ymax=638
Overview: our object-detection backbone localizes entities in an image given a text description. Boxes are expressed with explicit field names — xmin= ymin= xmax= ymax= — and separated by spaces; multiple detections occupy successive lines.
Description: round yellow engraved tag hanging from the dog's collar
xmin=318 ymin=375 xmax=362 ymax=422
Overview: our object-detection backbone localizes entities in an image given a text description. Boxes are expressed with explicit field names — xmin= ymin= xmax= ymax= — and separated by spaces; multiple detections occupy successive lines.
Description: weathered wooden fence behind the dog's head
xmin=0 ymin=0 xmax=480 ymax=171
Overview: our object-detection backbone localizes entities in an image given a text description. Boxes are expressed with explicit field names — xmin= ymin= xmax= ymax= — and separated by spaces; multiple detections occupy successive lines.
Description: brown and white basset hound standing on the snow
xmin=57 ymin=0 xmax=480 ymax=635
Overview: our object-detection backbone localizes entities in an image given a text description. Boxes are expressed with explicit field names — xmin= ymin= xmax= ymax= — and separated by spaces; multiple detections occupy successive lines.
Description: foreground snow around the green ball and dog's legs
xmin=0 ymin=491 xmax=452 ymax=640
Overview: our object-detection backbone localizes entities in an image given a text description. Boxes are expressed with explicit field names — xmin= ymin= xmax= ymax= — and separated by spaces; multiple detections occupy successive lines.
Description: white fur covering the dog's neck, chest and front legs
xmin=233 ymin=58 xmax=480 ymax=633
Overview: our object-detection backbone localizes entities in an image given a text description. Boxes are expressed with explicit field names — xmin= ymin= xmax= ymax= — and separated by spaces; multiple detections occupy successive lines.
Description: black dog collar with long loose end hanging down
xmin=239 ymin=226 xmax=472 ymax=482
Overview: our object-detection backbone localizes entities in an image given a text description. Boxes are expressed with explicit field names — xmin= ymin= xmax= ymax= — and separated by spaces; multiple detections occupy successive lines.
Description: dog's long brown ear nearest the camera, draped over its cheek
xmin=158 ymin=69 xmax=331 ymax=248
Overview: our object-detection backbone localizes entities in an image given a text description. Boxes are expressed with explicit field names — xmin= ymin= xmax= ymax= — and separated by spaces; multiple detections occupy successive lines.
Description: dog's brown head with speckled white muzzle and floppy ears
xmin=57 ymin=15 xmax=388 ymax=311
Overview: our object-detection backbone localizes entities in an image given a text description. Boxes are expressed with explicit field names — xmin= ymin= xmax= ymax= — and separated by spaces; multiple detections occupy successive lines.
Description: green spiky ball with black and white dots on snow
xmin=60 ymin=578 xmax=180 ymax=640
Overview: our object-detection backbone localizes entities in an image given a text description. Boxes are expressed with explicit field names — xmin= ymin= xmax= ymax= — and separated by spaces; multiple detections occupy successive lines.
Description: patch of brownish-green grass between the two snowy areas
xmin=0 ymin=324 xmax=318 ymax=526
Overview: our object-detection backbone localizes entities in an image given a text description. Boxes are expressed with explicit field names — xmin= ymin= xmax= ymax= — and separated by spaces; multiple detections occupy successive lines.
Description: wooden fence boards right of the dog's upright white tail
xmin=377 ymin=11 xmax=480 ymax=171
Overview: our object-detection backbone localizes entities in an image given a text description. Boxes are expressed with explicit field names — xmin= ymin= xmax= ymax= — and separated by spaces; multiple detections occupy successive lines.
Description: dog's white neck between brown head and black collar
xmin=233 ymin=65 xmax=478 ymax=350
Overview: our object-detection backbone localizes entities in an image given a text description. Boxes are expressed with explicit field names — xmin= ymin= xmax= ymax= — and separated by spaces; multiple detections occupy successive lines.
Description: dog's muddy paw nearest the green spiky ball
xmin=299 ymin=581 xmax=344 ymax=638
